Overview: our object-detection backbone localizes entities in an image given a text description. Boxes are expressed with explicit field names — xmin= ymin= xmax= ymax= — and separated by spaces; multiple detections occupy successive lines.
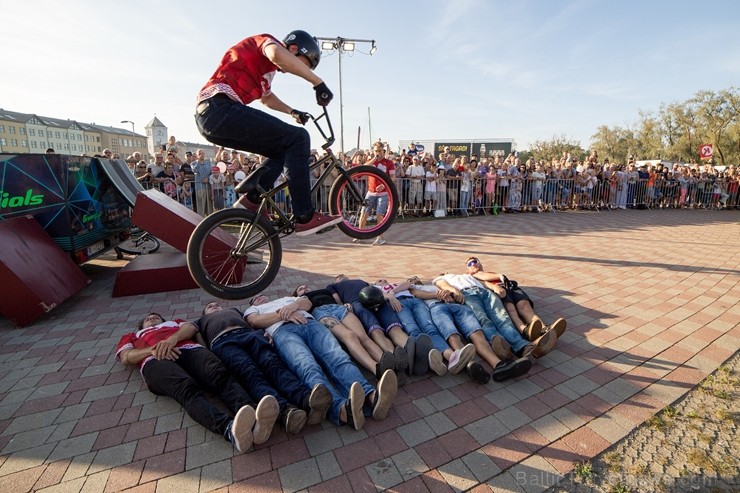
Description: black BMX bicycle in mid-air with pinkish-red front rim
xmin=187 ymin=107 xmax=399 ymax=300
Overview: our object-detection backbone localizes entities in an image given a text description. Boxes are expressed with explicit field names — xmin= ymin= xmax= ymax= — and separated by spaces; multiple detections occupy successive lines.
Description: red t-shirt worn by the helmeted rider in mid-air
xmin=197 ymin=34 xmax=280 ymax=104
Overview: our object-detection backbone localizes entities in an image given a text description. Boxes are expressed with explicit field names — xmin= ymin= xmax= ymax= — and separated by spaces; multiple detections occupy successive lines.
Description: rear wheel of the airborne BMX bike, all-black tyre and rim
xmin=187 ymin=208 xmax=283 ymax=300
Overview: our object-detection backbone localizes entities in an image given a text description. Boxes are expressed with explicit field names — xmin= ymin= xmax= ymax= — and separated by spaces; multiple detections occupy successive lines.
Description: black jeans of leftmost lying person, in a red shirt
xmin=141 ymin=348 xmax=256 ymax=438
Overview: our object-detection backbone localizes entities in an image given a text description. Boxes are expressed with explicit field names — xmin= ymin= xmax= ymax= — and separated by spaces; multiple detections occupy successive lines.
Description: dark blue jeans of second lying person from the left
xmin=211 ymin=329 xmax=311 ymax=412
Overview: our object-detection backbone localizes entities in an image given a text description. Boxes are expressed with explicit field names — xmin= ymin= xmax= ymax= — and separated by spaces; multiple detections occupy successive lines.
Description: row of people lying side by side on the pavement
xmin=116 ymin=258 xmax=566 ymax=452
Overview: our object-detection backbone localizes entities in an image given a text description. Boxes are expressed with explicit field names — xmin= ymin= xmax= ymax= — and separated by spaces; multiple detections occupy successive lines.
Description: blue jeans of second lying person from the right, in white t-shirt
xmin=462 ymin=288 xmax=527 ymax=353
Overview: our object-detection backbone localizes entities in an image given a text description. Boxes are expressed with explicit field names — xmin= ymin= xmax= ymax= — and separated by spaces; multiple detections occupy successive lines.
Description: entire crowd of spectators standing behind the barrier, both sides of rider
xmin=124 ymin=138 xmax=740 ymax=217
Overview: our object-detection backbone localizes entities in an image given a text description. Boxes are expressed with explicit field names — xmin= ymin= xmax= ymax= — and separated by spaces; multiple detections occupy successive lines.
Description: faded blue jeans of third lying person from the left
xmin=272 ymin=319 xmax=375 ymax=424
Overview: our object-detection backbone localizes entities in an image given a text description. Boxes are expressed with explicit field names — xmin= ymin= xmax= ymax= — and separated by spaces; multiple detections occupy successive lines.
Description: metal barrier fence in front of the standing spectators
xmin=137 ymin=178 xmax=740 ymax=217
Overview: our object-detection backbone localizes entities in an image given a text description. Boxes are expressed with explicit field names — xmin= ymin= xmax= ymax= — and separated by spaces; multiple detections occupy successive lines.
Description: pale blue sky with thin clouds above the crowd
xmin=0 ymin=0 xmax=740 ymax=151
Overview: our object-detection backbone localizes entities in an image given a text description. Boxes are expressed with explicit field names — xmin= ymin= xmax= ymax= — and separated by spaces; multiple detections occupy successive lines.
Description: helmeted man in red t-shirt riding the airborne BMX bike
xmin=195 ymin=30 xmax=341 ymax=236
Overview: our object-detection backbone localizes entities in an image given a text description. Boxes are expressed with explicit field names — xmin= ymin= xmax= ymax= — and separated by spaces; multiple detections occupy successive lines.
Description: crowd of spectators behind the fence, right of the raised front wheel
xmin=393 ymin=150 xmax=740 ymax=216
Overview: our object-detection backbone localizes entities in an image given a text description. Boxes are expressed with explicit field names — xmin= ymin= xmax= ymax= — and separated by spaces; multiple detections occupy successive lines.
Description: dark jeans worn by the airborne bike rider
xmin=195 ymin=94 xmax=314 ymax=216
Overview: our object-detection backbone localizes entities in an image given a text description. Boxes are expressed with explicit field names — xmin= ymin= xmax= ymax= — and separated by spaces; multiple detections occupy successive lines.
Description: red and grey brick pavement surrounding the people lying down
xmin=0 ymin=210 xmax=740 ymax=493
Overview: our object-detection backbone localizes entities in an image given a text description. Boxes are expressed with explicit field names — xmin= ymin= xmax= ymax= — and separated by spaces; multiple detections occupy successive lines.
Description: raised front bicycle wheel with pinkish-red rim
xmin=329 ymin=166 xmax=398 ymax=240
